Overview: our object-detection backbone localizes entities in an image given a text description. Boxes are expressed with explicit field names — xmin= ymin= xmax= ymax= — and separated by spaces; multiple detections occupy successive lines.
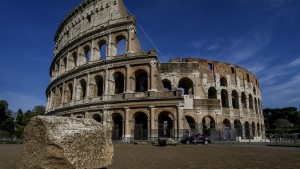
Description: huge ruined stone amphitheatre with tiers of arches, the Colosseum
xmin=46 ymin=0 xmax=265 ymax=142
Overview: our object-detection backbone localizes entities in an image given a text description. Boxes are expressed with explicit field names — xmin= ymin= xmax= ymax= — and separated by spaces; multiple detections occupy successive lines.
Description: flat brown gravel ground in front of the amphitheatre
xmin=0 ymin=144 xmax=300 ymax=169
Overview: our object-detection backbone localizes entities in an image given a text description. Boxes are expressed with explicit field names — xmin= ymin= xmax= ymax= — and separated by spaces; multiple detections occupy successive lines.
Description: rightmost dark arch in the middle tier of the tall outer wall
xmin=135 ymin=69 xmax=148 ymax=92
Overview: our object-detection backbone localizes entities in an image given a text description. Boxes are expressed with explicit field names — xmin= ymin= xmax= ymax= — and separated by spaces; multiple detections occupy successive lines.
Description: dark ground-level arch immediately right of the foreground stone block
xmin=112 ymin=113 xmax=123 ymax=140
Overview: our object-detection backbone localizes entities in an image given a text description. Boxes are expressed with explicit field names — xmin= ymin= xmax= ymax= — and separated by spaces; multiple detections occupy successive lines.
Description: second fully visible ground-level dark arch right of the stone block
xmin=134 ymin=112 xmax=148 ymax=140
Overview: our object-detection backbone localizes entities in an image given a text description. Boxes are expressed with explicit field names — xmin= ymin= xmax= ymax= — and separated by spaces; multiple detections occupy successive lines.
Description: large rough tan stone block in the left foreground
xmin=17 ymin=116 xmax=113 ymax=169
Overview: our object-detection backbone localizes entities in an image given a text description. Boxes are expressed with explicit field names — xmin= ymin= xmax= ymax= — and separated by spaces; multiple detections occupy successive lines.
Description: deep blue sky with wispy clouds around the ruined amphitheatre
xmin=0 ymin=0 xmax=300 ymax=111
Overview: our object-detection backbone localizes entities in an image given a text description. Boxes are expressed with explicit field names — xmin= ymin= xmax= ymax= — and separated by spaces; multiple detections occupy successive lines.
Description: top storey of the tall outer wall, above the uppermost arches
xmin=54 ymin=0 xmax=130 ymax=55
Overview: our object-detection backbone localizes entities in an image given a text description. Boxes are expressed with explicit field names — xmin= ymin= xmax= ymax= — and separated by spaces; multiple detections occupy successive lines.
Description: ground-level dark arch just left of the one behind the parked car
xmin=158 ymin=112 xmax=174 ymax=138
